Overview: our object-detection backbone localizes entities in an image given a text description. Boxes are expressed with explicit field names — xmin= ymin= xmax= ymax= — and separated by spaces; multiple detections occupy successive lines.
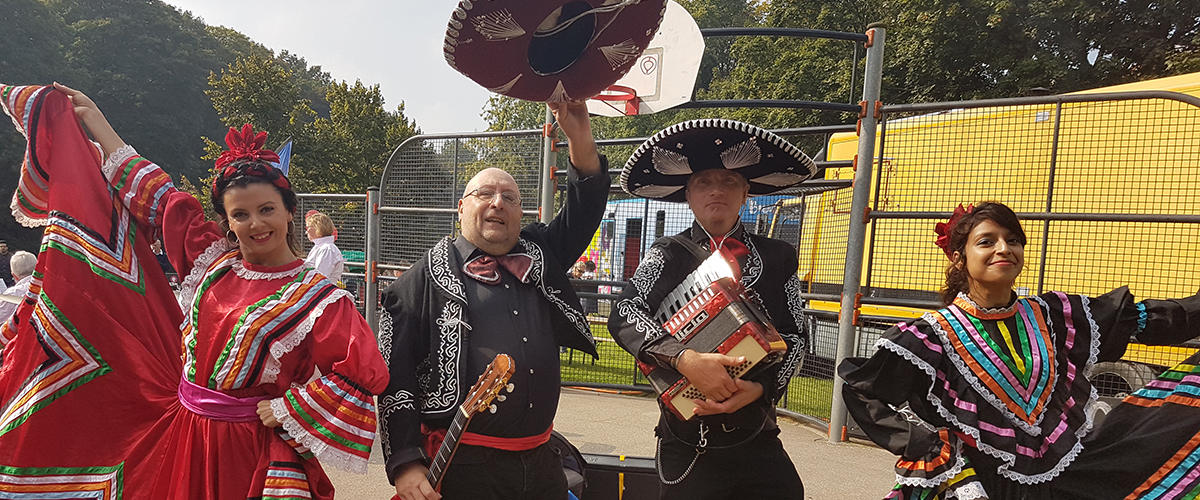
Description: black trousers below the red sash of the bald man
xmin=440 ymin=445 xmax=566 ymax=500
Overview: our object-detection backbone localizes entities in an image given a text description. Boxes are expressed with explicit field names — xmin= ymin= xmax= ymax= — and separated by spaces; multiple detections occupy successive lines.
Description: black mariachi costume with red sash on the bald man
xmin=379 ymin=158 xmax=611 ymax=498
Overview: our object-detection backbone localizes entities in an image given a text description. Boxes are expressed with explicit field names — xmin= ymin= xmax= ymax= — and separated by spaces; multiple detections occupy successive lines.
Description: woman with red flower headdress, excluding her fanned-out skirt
xmin=56 ymin=85 xmax=388 ymax=500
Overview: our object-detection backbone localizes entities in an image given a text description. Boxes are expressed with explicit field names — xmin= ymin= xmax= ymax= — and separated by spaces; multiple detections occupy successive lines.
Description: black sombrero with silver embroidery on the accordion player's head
xmin=620 ymin=119 xmax=817 ymax=201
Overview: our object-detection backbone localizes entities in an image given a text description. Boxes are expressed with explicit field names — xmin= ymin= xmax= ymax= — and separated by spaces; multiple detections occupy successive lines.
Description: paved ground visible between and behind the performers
xmin=328 ymin=388 xmax=895 ymax=500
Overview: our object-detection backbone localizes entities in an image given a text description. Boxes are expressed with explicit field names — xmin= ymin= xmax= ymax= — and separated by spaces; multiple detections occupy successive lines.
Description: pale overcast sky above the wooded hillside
xmin=166 ymin=0 xmax=490 ymax=133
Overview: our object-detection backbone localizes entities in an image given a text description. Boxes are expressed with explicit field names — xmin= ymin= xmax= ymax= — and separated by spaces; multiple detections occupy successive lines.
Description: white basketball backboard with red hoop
xmin=588 ymin=0 xmax=704 ymax=116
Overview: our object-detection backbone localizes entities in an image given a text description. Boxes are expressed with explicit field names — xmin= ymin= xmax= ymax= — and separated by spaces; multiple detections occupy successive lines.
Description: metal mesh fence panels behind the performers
xmin=298 ymin=92 xmax=1200 ymax=436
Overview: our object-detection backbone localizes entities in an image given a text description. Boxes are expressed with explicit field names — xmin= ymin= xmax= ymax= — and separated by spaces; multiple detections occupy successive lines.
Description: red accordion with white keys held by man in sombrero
xmin=637 ymin=251 xmax=787 ymax=420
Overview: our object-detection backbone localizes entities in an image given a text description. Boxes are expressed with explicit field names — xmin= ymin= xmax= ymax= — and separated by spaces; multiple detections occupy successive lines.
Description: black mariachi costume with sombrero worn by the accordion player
xmin=608 ymin=120 xmax=815 ymax=498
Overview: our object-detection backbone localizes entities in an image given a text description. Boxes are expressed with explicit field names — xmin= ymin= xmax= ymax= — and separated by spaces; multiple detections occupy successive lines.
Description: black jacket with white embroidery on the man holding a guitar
xmin=378 ymin=156 xmax=612 ymax=481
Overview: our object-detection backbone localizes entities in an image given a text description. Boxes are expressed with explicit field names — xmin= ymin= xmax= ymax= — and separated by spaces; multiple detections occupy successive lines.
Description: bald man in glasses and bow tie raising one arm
xmin=379 ymin=102 xmax=611 ymax=500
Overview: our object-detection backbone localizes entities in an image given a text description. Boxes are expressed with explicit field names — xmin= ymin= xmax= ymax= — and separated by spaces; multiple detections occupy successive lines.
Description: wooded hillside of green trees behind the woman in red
xmin=0 ymin=0 xmax=419 ymax=251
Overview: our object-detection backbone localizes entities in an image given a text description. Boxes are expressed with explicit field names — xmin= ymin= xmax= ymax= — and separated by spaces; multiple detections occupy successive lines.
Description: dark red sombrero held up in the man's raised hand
xmin=443 ymin=0 xmax=666 ymax=102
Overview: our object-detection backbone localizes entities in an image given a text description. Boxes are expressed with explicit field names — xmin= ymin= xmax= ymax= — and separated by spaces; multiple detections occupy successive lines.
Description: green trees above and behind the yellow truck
xmin=707 ymin=0 xmax=1200 ymax=115
